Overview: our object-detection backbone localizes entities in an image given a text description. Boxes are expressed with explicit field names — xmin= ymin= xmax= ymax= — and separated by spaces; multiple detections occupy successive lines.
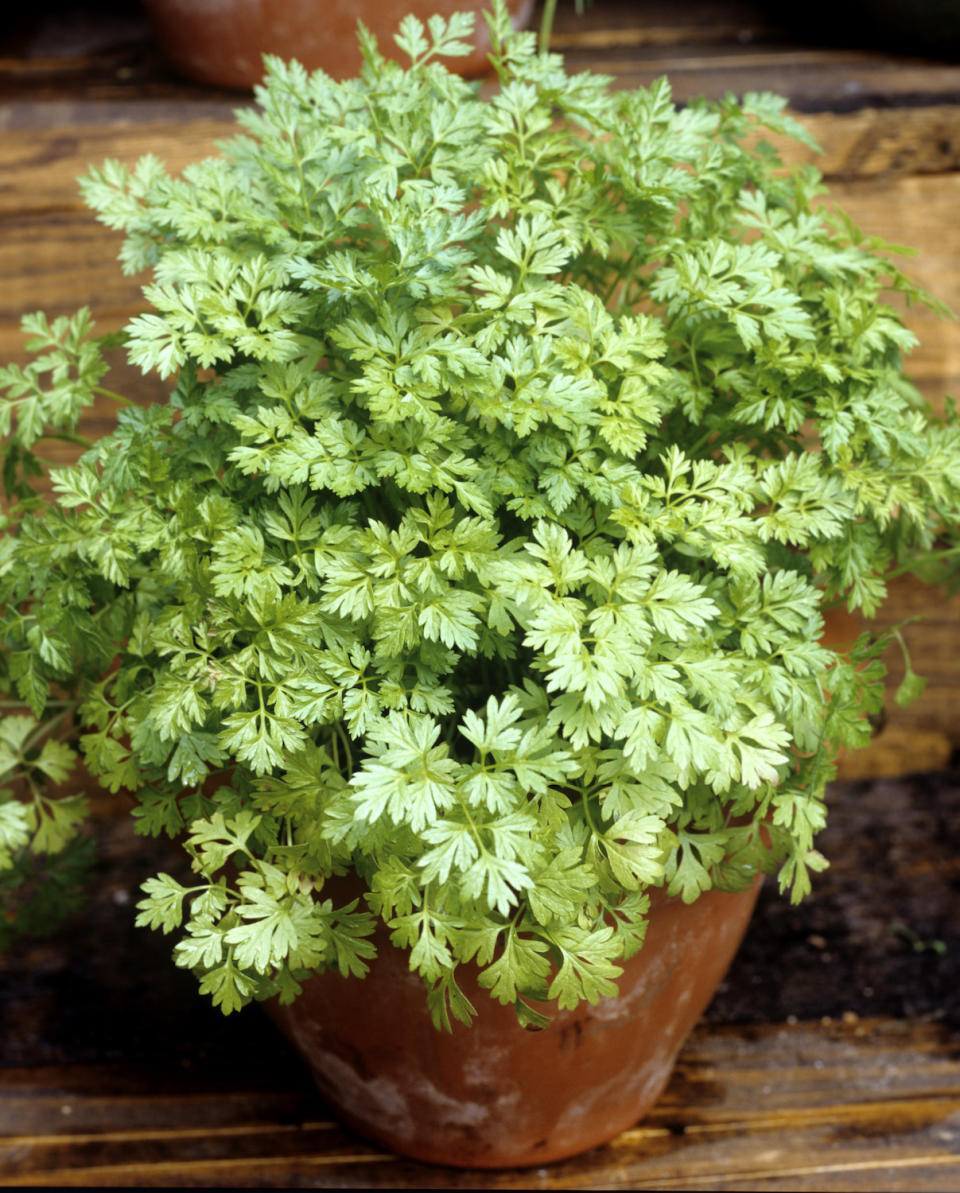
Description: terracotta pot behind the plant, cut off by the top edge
xmin=144 ymin=0 xmax=533 ymax=88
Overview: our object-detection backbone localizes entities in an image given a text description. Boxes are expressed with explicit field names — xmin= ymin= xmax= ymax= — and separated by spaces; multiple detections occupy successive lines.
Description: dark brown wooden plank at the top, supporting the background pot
xmin=0 ymin=0 xmax=960 ymax=111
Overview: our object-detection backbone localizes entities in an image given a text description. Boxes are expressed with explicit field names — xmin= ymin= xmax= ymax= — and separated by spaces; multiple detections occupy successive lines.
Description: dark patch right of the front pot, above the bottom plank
xmin=707 ymin=771 xmax=960 ymax=1024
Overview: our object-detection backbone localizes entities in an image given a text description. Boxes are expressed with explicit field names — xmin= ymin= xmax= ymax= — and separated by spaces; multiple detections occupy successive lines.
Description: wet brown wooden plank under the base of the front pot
xmin=0 ymin=1020 xmax=960 ymax=1189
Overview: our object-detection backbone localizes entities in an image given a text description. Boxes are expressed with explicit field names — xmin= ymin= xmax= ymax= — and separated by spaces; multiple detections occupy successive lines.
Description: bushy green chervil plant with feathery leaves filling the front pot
xmin=0 ymin=7 xmax=960 ymax=1024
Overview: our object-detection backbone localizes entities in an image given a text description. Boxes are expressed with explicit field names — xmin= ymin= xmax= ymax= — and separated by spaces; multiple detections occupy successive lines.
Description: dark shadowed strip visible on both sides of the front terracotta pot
xmin=0 ymin=772 xmax=960 ymax=1070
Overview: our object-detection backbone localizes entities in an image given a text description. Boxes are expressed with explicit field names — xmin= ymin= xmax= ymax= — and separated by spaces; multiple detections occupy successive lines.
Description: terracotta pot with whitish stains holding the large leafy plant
xmin=270 ymin=882 xmax=760 ymax=1168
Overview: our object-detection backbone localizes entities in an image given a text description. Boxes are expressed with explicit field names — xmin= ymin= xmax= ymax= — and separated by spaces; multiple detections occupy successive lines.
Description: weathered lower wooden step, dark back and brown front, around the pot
xmin=0 ymin=773 xmax=960 ymax=1191
